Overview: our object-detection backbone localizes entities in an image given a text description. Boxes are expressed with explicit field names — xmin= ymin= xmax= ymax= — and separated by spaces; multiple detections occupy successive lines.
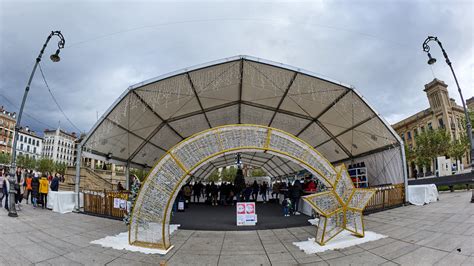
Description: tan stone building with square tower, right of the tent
xmin=392 ymin=79 xmax=468 ymax=177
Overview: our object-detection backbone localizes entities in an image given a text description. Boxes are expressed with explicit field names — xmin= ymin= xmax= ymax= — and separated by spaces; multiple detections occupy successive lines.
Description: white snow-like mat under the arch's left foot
xmin=91 ymin=224 xmax=180 ymax=255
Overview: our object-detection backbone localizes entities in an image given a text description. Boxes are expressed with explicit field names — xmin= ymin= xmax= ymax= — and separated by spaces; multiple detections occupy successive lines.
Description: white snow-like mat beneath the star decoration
xmin=293 ymin=230 xmax=387 ymax=254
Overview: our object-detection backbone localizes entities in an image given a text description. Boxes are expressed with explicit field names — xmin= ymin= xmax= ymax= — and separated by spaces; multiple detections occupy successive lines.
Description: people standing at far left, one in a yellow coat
xmin=0 ymin=168 xmax=64 ymax=210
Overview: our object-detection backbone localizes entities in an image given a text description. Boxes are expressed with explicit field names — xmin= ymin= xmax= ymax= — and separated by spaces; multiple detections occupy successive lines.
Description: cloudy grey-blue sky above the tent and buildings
xmin=0 ymin=0 xmax=474 ymax=136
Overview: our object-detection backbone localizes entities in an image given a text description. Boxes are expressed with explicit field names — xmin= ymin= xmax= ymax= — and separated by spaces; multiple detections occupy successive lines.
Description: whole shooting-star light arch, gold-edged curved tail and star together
xmin=129 ymin=124 xmax=373 ymax=250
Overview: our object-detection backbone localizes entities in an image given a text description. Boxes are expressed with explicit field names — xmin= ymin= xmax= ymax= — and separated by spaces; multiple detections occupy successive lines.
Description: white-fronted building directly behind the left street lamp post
xmin=16 ymin=127 xmax=43 ymax=159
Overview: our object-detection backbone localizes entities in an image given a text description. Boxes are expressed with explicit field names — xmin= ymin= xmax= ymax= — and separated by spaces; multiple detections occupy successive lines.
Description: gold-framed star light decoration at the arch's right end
xmin=303 ymin=165 xmax=375 ymax=246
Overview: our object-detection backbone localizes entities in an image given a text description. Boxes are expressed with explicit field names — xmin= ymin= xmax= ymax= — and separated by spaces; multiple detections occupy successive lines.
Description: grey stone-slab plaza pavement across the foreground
xmin=0 ymin=191 xmax=474 ymax=265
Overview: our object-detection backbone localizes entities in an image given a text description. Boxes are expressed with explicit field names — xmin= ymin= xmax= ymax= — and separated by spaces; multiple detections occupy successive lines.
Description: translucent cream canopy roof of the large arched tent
xmin=82 ymin=56 xmax=401 ymax=182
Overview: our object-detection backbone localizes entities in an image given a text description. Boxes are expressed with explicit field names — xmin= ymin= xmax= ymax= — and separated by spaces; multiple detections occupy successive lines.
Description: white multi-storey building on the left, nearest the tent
xmin=43 ymin=127 xmax=77 ymax=166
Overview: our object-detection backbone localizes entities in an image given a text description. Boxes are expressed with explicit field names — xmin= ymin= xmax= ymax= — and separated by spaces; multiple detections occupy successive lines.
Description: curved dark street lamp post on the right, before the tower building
xmin=423 ymin=36 xmax=474 ymax=172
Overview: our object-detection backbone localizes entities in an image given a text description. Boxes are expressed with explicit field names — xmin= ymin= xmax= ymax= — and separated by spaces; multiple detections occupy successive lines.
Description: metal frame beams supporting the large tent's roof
xmin=76 ymin=55 xmax=407 ymax=210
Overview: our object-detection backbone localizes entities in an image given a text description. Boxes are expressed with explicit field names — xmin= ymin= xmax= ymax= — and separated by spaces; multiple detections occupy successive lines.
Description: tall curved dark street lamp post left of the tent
xmin=8 ymin=31 xmax=66 ymax=217
